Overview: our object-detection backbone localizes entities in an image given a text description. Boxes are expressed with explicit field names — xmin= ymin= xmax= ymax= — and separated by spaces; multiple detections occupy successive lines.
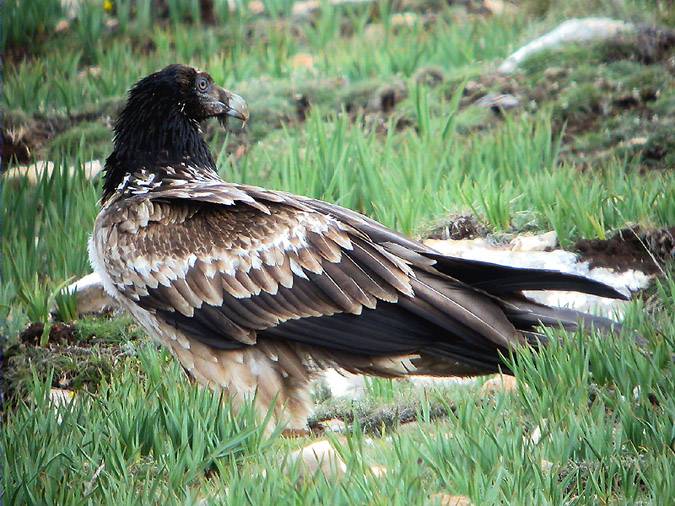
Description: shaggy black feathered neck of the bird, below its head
xmin=102 ymin=107 xmax=216 ymax=202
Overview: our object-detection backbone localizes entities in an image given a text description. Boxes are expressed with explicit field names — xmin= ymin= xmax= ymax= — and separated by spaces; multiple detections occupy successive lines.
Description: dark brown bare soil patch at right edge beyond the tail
xmin=574 ymin=227 xmax=675 ymax=274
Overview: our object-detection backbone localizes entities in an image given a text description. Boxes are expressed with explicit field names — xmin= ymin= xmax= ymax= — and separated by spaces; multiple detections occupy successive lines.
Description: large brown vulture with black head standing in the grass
xmin=89 ymin=64 xmax=627 ymax=431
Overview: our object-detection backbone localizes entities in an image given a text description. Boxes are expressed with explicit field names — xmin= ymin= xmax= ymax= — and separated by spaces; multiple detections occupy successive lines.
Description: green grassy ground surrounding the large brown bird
xmin=0 ymin=0 xmax=675 ymax=505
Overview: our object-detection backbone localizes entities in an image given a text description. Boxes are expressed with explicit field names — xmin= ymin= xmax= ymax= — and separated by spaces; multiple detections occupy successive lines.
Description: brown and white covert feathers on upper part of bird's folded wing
xmin=103 ymin=194 xmax=412 ymax=347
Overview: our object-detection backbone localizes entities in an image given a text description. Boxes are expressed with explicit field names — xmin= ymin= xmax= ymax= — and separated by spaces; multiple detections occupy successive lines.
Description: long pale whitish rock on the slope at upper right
xmin=499 ymin=18 xmax=635 ymax=74
